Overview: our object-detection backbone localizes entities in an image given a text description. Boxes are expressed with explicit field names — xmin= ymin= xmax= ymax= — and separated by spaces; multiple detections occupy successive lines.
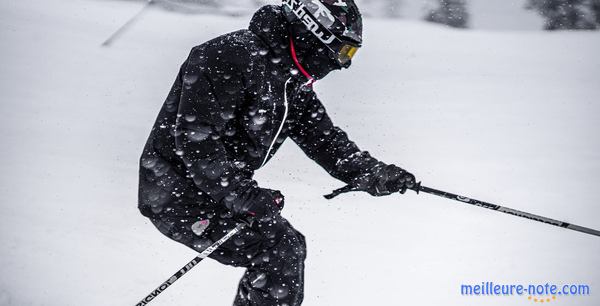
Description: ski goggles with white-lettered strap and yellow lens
xmin=283 ymin=0 xmax=360 ymax=67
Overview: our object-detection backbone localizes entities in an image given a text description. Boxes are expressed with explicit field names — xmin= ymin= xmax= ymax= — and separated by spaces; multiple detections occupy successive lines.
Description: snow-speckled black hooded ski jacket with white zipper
xmin=139 ymin=6 xmax=385 ymax=218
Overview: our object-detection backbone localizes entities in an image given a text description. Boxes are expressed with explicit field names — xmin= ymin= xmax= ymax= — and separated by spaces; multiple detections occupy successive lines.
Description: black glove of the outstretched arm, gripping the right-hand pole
xmin=350 ymin=164 xmax=416 ymax=197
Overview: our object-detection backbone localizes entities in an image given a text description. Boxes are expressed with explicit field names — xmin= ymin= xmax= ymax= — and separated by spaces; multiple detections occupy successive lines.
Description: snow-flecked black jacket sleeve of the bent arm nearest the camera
xmin=174 ymin=45 xmax=276 ymax=213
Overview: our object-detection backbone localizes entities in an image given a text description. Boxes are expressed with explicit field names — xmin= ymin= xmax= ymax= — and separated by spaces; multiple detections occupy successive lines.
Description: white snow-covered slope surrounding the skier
xmin=0 ymin=0 xmax=600 ymax=306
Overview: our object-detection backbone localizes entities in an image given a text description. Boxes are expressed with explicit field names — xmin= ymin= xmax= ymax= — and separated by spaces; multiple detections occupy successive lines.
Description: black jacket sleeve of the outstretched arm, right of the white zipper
xmin=290 ymin=90 xmax=385 ymax=184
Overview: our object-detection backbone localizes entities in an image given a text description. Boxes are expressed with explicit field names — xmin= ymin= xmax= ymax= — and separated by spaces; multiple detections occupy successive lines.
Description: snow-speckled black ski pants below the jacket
xmin=151 ymin=215 xmax=306 ymax=306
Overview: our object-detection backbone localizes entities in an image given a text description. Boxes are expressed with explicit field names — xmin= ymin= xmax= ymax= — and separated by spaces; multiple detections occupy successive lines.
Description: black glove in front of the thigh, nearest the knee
xmin=225 ymin=186 xmax=284 ymax=224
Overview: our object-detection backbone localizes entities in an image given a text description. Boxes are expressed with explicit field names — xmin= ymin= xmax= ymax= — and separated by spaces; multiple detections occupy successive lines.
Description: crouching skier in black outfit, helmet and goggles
xmin=139 ymin=0 xmax=415 ymax=306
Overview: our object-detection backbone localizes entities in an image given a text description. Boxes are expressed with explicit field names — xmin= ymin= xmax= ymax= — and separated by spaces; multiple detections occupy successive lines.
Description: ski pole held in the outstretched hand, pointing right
xmin=325 ymin=182 xmax=600 ymax=236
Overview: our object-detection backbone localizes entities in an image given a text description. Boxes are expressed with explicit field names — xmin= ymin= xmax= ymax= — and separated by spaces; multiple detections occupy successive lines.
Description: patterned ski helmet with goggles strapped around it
xmin=283 ymin=0 xmax=362 ymax=66
